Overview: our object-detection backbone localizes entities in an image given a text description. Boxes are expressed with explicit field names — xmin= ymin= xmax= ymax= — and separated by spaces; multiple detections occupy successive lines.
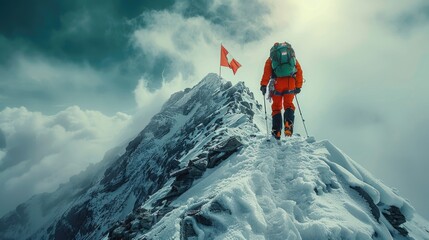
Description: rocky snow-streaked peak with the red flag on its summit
xmin=0 ymin=74 xmax=261 ymax=239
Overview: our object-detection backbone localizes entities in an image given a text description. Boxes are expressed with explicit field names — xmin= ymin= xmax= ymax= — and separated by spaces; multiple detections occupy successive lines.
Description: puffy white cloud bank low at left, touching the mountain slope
xmin=0 ymin=106 xmax=131 ymax=215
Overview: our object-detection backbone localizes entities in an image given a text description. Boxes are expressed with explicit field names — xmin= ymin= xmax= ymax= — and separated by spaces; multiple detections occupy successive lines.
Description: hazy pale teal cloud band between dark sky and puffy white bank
xmin=0 ymin=54 xmax=134 ymax=113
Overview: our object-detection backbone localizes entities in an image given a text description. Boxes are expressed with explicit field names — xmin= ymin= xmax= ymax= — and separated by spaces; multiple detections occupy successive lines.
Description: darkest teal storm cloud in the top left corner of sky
xmin=0 ymin=0 xmax=173 ymax=66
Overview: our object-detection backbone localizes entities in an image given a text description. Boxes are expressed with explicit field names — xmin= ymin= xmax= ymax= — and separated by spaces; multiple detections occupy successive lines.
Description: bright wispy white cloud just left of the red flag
xmin=133 ymin=11 xmax=216 ymax=89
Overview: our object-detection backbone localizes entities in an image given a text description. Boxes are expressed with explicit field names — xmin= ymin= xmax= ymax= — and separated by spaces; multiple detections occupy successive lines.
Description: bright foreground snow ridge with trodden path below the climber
xmin=145 ymin=132 xmax=429 ymax=240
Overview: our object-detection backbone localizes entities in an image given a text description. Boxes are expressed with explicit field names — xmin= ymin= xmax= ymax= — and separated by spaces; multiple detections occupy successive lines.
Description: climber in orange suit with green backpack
xmin=261 ymin=42 xmax=303 ymax=139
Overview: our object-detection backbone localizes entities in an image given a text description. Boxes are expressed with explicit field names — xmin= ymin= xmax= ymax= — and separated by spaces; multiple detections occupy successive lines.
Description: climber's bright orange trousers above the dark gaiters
xmin=271 ymin=77 xmax=295 ymax=116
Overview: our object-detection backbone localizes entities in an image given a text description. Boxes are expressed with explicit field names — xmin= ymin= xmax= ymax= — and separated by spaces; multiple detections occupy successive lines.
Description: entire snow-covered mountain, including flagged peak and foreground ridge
xmin=0 ymin=74 xmax=429 ymax=239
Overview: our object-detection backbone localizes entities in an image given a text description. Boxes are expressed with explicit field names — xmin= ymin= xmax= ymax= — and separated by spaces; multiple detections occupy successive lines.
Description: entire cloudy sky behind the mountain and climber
xmin=0 ymin=0 xmax=429 ymax=219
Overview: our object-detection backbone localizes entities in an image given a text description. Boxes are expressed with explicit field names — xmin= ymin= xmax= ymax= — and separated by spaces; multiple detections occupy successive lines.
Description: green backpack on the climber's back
xmin=270 ymin=42 xmax=296 ymax=77
